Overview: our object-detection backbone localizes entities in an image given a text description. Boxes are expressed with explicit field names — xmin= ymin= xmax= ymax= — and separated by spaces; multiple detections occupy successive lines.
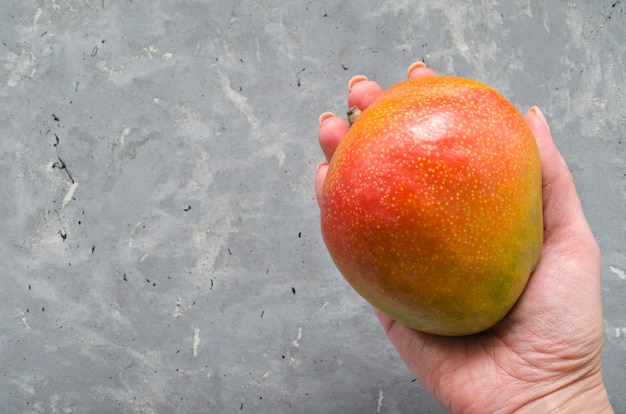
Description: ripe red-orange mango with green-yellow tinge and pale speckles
xmin=321 ymin=76 xmax=543 ymax=336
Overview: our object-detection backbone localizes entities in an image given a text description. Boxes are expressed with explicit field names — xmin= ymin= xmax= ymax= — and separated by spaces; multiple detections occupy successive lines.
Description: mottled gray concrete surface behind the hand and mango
xmin=0 ymin=0 xmax=626 ymax=413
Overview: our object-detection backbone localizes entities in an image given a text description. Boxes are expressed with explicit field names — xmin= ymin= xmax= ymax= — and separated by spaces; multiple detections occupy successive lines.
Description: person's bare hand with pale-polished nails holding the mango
xmin=315 ymin=62 xmax=613 ymax=413
